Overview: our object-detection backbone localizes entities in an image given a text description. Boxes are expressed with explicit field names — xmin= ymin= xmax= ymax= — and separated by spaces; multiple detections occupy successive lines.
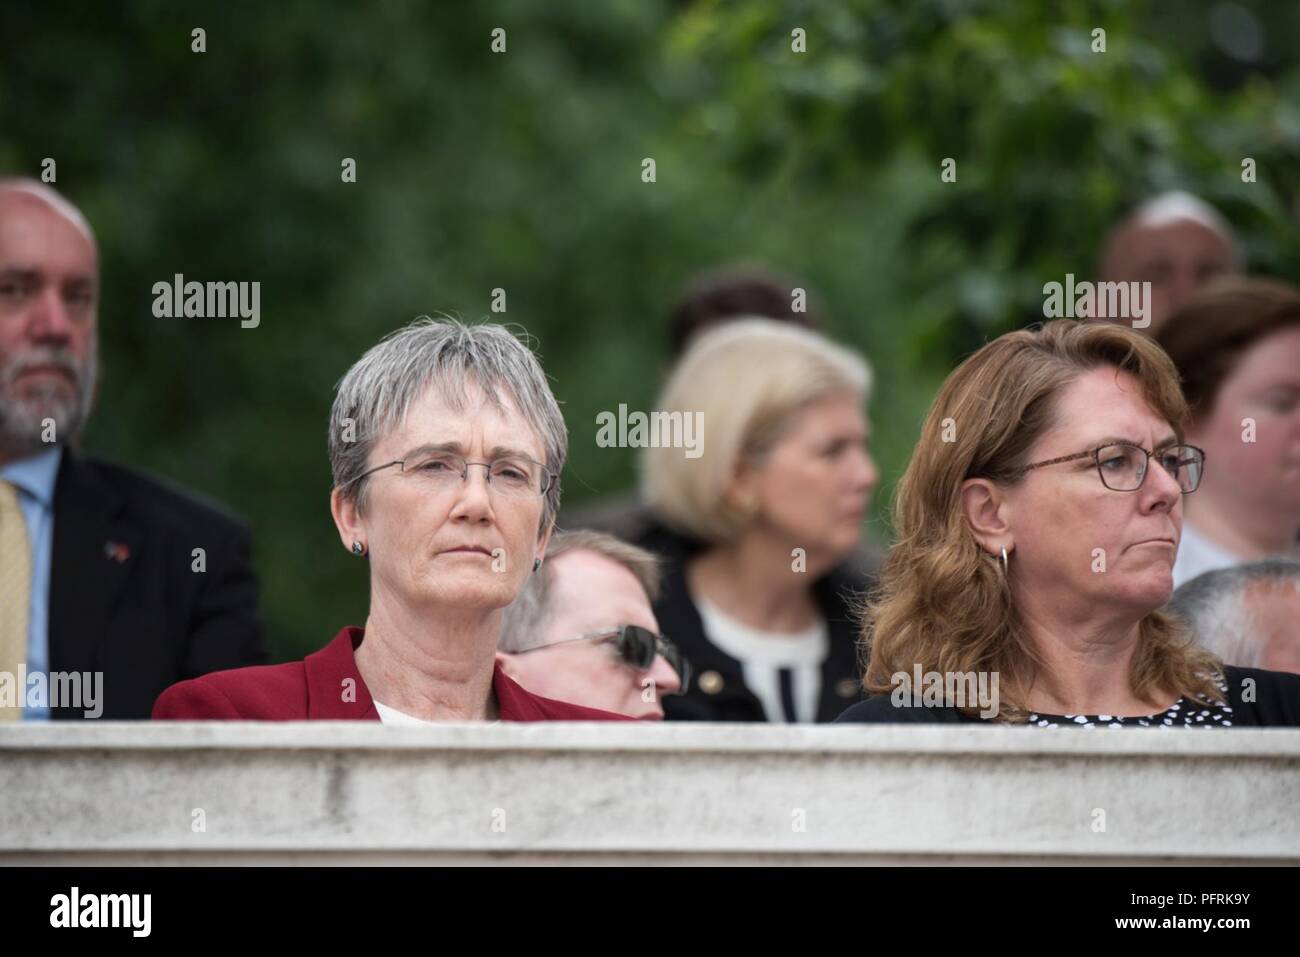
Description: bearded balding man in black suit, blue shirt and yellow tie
xmin=0 ymin=179 xmax=265 ymax=720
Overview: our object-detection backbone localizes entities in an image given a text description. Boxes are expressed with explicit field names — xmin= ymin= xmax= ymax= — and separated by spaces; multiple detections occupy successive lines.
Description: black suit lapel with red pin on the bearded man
xmin=49 ymin=449 xmax=143 ymax=671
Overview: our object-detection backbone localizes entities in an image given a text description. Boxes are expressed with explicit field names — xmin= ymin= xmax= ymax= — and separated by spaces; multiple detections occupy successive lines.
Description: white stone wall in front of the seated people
xmin=0 ymin=722 xmax=1300 ymax=863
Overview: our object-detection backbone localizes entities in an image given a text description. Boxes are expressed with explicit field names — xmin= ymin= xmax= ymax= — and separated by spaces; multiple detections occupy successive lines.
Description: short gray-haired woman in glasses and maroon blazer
xmin=153 ymin=319 xmax=621 ymax=724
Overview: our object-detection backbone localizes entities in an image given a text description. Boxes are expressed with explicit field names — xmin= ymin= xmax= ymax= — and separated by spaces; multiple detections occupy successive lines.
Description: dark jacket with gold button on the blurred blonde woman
xmin=636 ymin=524 xmax=870 ymax=722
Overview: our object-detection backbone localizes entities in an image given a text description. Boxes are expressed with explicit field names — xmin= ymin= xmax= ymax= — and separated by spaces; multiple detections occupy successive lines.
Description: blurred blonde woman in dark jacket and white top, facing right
xmin=640 ymin=319 xmax=878 ymax=722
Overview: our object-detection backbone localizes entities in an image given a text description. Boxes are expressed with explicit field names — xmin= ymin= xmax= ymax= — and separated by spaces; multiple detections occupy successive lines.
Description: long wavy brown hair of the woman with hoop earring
xmin=863 ymin=320 xmax=1223 ymax=722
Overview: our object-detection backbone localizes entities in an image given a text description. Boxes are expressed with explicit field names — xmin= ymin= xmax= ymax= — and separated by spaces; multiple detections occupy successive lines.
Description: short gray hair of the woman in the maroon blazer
xmin=329 ymin=316 xmax=568 ymax=534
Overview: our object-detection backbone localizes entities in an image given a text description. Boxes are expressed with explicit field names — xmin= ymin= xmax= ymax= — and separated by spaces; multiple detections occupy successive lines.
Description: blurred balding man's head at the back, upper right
xmin=1101 ymin=192 xmax=1242 ymax=335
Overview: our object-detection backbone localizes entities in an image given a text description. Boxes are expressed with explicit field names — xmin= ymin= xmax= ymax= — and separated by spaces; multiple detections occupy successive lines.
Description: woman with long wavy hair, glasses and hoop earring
xmin=840 ymin=320 xmax=1300 ymax=727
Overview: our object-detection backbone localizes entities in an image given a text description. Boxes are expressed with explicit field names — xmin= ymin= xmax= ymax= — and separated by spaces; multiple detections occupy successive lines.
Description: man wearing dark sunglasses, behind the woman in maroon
xmin=497 ymin=531 xmax=690 ymax=720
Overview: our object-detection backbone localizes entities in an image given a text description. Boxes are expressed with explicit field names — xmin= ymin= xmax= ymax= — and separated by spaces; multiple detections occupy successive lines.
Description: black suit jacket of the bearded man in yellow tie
xmin=48 ymin=449 xmax=267 ymax=720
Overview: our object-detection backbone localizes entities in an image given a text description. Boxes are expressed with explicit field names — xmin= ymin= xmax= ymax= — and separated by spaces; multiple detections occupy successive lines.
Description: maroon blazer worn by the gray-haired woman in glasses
xmin=153 ymin=625 xmax=633 ymax=722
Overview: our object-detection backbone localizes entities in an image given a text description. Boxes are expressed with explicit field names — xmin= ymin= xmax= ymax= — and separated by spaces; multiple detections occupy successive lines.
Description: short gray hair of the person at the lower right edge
xmin=1169 ymin=558 xmax=1300 ymax=668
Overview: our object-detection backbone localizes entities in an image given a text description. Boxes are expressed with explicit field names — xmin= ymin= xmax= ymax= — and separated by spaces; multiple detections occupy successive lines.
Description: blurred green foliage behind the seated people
xmin=0 ymin=0 xmax=1300 ymax=659
